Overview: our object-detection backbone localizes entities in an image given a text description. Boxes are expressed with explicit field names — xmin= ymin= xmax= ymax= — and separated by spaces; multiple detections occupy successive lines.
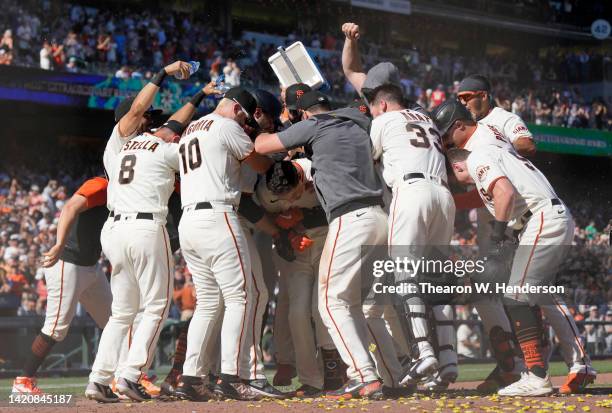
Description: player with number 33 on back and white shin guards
xmin=370 ymin=84 xmax=457 ymax=386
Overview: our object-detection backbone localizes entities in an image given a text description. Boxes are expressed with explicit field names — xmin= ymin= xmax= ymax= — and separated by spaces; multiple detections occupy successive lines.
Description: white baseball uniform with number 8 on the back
xmin=90 ymin=133 xmax=179 ymax=385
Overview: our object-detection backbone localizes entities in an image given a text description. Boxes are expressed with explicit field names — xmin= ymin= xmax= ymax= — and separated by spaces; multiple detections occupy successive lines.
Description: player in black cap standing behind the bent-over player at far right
xmin=450 ymin=84 xmax=597 ymax=394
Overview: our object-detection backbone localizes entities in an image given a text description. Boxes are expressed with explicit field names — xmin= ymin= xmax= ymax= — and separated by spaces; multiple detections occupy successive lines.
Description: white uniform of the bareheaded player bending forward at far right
xmin=467 ymin=146 xmax=574 ymax=298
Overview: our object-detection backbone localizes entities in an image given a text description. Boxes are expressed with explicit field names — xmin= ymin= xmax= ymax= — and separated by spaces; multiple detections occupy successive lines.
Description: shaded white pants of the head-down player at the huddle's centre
xmin=275 ymin=227 xmax=334 ymax=389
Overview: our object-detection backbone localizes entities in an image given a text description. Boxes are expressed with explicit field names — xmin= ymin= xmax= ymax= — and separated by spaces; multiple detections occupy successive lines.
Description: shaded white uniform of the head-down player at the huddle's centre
xmin=257 ymin=158 xmax=335 ymax=389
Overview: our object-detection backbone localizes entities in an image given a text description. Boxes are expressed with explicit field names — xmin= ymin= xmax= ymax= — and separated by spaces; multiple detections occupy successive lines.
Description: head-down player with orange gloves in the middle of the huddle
xmin=257 ymin=158 xmax=342 ymax=397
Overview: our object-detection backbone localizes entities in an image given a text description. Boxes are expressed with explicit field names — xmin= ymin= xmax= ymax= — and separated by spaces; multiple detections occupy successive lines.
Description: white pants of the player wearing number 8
xmin=89 ymin=219 xmax=174 ymax=385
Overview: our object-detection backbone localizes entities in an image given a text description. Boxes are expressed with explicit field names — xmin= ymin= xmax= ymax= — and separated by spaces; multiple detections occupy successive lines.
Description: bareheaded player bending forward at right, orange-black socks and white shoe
xmin=448 ymin=143 xmax=574 ymax=396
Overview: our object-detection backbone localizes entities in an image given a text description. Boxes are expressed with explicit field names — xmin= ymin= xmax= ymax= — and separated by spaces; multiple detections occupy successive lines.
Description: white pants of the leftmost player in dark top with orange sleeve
xmin=41 ymin=260 xmax=113 ymax=341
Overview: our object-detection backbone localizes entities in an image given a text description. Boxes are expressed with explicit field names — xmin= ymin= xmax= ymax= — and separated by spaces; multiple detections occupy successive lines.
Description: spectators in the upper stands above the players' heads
xmin=0 ymin=0 xmax=612 ymax=130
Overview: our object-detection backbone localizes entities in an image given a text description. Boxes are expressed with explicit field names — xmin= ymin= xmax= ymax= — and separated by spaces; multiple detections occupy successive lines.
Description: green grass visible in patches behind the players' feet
xmin=0 ymin=360 xmax=612 ymax=400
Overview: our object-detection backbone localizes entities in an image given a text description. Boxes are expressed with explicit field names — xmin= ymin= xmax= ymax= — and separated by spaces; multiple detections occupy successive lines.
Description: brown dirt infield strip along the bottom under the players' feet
xmin=0 ymin=373 xmax=612 ymax=413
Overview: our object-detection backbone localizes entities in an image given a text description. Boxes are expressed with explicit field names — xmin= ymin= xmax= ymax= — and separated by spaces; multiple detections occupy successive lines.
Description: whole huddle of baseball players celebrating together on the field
xmin=13 ymin=23 xmax=596 ymax=403
